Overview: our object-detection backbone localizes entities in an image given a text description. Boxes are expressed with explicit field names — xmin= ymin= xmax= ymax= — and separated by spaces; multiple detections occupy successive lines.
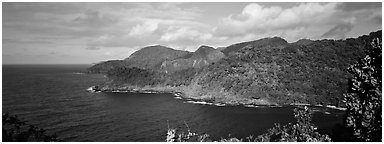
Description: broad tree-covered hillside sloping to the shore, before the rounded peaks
xmin=89 ymin=31 xmax=381 ymax=105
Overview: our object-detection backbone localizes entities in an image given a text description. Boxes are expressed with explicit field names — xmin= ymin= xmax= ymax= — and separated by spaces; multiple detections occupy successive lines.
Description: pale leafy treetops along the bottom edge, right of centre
xmin=166 ymin=107 xmax=331 ymax=142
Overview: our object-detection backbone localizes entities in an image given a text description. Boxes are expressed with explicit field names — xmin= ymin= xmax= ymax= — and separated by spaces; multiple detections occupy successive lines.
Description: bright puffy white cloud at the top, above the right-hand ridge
xmin=216 ymin=3 xmax=336 ymax=36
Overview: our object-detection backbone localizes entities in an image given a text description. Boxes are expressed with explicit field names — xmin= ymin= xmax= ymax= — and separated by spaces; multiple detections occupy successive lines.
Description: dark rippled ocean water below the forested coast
xmin=2 ymin=65 xmax=343 ymax=142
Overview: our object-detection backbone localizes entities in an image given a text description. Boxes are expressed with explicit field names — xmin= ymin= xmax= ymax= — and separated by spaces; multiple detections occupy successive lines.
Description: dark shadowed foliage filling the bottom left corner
xmin=2 ymin=113 xmax=59 ymax=142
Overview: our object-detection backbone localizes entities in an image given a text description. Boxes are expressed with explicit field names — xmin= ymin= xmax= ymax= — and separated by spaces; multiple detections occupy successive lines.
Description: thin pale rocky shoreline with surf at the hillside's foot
xmin=87 ymin=85 xmax=346 ymax=111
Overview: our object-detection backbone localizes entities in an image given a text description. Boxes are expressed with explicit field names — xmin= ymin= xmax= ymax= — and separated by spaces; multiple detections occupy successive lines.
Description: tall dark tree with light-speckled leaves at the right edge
xmin=344 ymin=35 xmax=382 ymax=141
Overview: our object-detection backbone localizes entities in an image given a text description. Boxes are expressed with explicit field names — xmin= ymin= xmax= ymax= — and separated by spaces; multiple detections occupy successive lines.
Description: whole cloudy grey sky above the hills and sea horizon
xmin=2 ymin=2 xmax=382 ymax=64
